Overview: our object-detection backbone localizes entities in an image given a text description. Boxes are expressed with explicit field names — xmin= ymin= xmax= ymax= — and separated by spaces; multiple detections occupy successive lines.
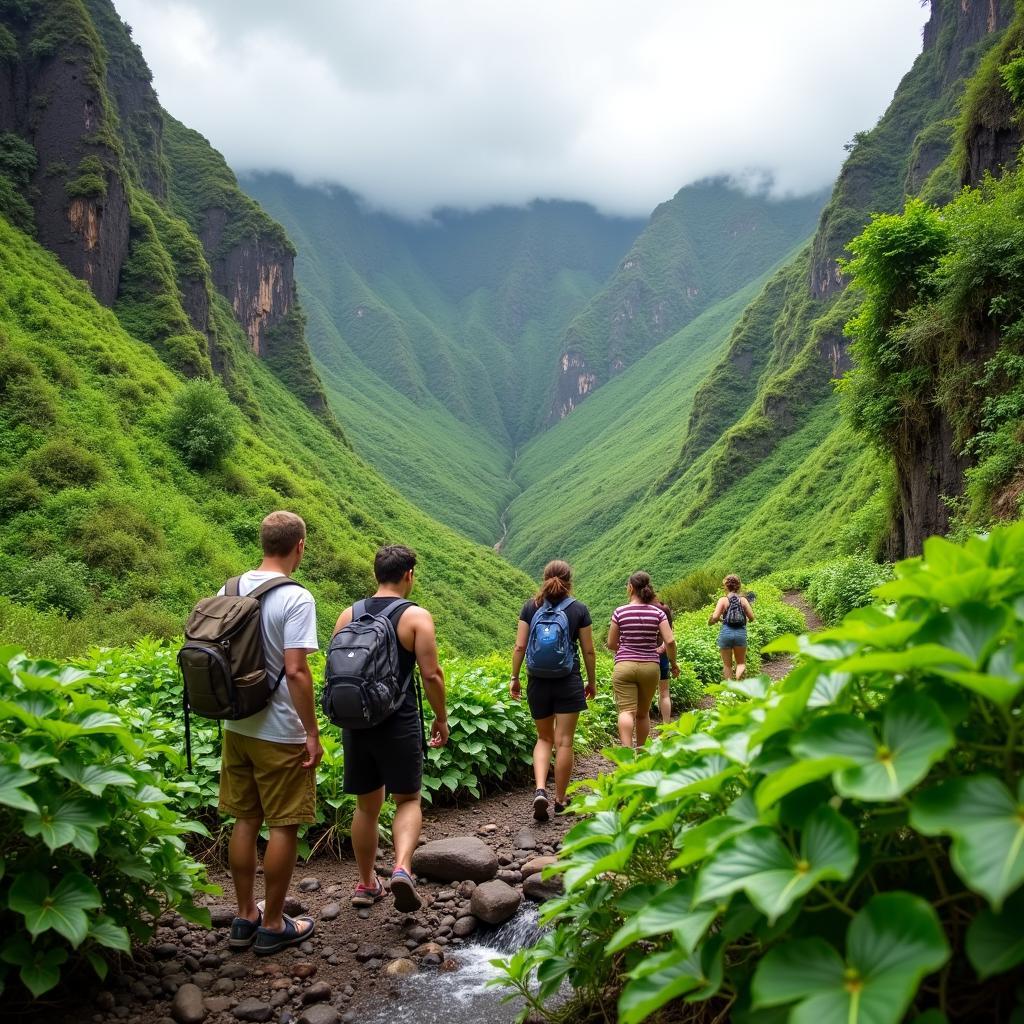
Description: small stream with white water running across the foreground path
xmin=360 ymin=905 xmax=541 ymax=1024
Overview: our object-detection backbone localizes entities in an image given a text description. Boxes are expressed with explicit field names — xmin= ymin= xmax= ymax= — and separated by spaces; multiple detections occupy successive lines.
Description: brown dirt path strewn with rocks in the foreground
xmin=44 ymin=755 xmax=610 ymax=1024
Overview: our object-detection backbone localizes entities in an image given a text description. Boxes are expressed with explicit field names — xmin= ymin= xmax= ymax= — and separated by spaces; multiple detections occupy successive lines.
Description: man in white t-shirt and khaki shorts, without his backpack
xmin=219 ymin=512 xmax=324 ymax=955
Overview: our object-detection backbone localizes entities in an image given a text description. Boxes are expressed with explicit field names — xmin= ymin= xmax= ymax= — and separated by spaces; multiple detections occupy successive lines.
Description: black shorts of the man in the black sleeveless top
xmin=341 ymin=706 xmax=423 ymax=796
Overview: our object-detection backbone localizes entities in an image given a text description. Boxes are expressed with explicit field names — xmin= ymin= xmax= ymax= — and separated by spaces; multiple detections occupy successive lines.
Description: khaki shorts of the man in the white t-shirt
xmin=219 ymin=730 xmax=316 ymax=827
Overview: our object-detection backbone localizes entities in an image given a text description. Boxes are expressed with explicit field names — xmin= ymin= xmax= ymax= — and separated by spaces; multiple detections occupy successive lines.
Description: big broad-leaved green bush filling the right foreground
xmin=501 ymin=523 xmax=1024 ymax=1024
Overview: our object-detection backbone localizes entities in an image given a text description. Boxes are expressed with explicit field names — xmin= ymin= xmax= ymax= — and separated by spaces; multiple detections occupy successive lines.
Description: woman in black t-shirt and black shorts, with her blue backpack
xmin=509 ymin=561 xmax=597 ymax=821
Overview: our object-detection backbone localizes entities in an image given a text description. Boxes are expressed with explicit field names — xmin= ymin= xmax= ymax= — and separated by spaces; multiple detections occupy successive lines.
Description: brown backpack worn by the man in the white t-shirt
xmin=178 ymin=577 xmax=299 ymax=771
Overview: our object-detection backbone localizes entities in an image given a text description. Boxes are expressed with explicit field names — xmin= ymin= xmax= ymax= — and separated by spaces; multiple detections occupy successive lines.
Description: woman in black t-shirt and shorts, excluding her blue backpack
xmin=509 ymin=561 xmax=597 ymax=821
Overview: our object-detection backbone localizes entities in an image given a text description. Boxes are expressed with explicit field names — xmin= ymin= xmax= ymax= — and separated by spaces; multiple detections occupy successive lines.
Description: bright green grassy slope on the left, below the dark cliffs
xmin=0 ymin=218 xmax=531 ymax=654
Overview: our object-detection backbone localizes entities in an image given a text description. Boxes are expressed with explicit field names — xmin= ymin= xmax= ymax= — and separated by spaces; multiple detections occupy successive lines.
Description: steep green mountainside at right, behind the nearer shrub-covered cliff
xmin=506 ymin=0 xmax=1019 ymax=602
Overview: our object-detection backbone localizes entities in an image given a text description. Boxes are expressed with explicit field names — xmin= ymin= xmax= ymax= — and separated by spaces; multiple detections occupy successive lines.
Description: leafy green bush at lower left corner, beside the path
xmin=0 ymin=648 xmax=213 ymax=997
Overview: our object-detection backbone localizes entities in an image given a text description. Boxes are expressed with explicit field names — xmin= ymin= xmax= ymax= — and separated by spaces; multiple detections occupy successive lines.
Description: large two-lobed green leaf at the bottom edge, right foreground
xmin=752 ymin=893 xmax=949 ymax=1024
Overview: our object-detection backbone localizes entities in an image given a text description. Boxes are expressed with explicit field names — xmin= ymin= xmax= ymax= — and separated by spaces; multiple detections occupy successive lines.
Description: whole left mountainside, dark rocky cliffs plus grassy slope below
xmin=0 ymin=0 xmax=530 ymax=652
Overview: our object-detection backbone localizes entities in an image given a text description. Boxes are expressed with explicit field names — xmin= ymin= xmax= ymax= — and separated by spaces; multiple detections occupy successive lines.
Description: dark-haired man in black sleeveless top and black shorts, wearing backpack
xmin=325 ymin=544 xmax=449 ymax=913
